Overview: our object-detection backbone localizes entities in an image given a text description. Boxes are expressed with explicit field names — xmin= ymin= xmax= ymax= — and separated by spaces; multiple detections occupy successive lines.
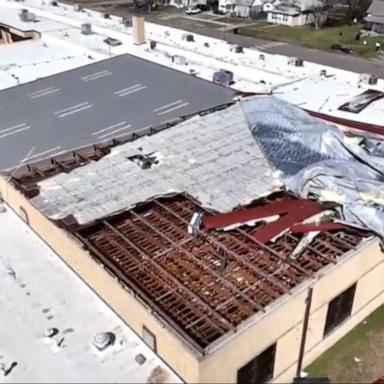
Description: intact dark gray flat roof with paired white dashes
xmin=0 ymin=55 xmax=234 ymax=169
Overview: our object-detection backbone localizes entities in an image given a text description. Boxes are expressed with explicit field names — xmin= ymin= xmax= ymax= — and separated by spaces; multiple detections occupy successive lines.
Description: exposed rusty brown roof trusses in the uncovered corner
xmin=74 ymin=195 xmax=362 ymax=351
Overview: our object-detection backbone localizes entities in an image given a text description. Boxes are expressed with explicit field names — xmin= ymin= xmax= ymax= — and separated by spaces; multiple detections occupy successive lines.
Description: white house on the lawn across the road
xmin=266 ymin=3 xmax=314 ymax=27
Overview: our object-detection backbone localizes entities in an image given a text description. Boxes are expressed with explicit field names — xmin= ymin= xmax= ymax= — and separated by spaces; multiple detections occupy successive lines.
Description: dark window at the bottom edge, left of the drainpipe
xmin=237 ymin=343 xmax=276 ymax=384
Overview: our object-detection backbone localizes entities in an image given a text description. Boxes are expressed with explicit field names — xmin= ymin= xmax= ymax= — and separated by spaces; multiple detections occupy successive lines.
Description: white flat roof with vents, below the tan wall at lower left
xmin=0 ymin=209 xmax=180 ymax=383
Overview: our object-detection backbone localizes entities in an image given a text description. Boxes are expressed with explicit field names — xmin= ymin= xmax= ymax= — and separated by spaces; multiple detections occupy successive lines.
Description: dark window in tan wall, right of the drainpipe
xmin=324 ymin=284 xmax=356 ymax=336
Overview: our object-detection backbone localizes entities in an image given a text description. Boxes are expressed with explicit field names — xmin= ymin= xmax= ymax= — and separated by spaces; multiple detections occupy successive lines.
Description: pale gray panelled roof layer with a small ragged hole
xmin=32 ymin=103 xmax=281 ymax=224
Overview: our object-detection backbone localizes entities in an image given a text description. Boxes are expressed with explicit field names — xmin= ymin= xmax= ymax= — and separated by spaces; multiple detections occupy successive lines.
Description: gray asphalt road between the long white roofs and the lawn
xmin=110 ymin=6 xmax=384 ymax=78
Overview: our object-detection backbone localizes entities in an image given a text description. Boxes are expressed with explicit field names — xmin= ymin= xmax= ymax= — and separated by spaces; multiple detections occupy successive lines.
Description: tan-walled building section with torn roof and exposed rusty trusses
xmin=0 ymin=97 xmax=384 ymax=383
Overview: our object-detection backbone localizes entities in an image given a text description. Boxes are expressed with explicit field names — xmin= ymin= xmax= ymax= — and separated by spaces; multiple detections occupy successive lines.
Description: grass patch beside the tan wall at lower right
xmin=305 ymin=306 xmax=384 ymax=383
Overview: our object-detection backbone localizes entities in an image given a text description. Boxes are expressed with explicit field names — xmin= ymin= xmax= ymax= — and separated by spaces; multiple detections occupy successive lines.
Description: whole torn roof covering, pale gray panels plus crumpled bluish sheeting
xmin=32 ymin=97 xmax=384 ymax=235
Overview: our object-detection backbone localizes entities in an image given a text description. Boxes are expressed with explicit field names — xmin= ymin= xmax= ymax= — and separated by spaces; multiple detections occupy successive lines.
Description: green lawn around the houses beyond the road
xmin=240 ymin=11 xmax=384 ymax=57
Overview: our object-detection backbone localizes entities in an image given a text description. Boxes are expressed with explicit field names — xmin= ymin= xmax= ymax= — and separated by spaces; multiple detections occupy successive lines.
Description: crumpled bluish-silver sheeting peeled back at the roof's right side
xmin=243 ymin=98 xmax=384 ymax=236
